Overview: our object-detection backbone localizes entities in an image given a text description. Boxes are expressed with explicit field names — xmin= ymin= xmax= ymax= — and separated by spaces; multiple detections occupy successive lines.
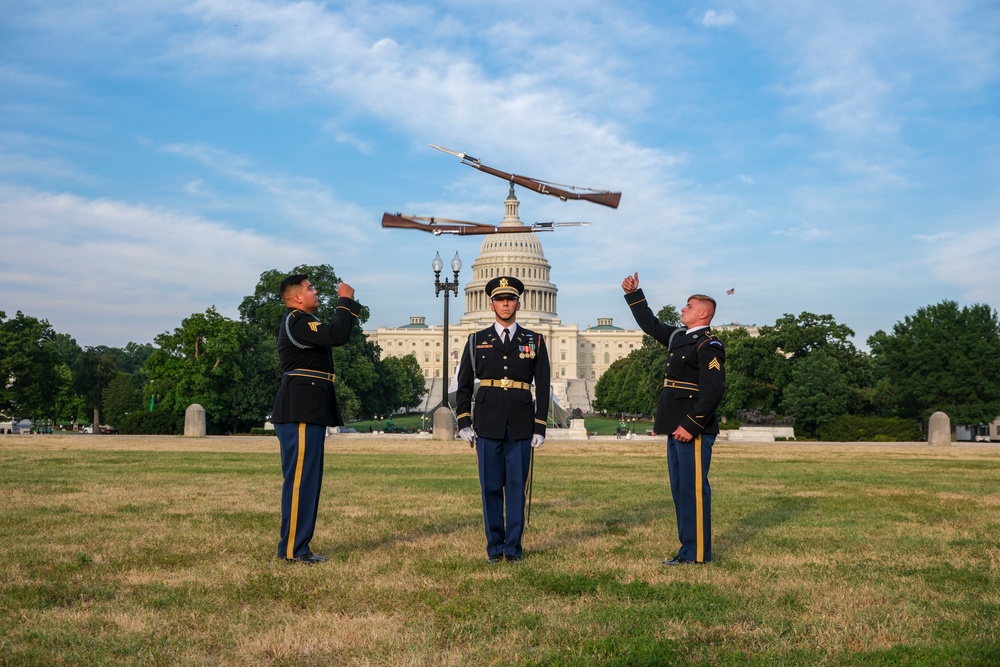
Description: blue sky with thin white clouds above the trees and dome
xmin=0 ymin=0 xmax=1000 ymax=347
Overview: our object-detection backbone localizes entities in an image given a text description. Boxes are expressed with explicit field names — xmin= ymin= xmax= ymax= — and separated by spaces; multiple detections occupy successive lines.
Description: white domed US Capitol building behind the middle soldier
xmin=365 ymin=185 xmax=642 ymax=412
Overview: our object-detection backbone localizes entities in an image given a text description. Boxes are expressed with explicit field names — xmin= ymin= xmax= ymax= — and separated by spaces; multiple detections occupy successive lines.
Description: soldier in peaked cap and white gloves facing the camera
xmin=456 ymin=276 xmax=550 ymax=563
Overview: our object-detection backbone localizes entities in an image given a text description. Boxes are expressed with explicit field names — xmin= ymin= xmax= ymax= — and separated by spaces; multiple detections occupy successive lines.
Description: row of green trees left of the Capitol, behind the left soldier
xmin=0 ymin=264 xmax=425 ymax=434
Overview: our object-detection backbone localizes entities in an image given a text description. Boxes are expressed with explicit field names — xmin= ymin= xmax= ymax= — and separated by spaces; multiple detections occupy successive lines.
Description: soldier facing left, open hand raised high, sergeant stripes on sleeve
xmin=622 ymin=273 xmax=726 ymax=565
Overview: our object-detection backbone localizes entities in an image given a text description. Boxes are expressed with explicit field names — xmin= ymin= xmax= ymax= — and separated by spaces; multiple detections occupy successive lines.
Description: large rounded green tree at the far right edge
xmin=868 ymin=300 xmax=1000 ymax=424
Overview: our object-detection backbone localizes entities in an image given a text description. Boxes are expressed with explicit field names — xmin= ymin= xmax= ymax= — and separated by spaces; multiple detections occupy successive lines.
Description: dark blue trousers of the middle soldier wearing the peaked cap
xmin=476 ymin=431 xmax=531 ymax=558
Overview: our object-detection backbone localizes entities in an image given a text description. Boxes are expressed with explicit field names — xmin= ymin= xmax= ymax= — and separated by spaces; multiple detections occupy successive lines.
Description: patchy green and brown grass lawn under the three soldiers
xmin=0 ymin=435 xmax=1000 ymax=666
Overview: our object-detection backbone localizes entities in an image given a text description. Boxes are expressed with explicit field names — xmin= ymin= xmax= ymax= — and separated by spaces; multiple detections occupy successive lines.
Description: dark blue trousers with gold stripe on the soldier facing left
xmin=667 ymin=433 xmax=716 ymax=563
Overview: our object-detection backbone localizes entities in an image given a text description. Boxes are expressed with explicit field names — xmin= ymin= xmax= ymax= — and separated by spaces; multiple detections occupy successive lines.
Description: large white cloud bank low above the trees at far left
xmin=0 ymin=184 xmax=302 ymax=346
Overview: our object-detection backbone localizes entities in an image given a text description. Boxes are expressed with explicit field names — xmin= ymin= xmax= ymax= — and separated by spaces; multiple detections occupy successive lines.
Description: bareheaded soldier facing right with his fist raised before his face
xmin=271 ymin=274 xmax=361 ymax=565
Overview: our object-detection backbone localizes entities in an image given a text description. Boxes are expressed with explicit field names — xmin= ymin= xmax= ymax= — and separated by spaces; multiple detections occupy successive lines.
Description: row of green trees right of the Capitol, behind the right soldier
xmin=594 ymin=300 xmax=1000 ymax=440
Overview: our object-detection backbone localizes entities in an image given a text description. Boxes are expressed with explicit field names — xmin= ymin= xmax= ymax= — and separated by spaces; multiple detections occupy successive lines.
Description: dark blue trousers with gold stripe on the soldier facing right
xmin=274 ymin=422 xmax=326 ymax=558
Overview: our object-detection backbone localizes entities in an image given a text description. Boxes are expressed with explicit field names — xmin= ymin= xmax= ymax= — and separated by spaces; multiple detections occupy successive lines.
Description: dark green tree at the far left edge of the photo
xmin=0 ymin=311 xmax=66 ymax=421
